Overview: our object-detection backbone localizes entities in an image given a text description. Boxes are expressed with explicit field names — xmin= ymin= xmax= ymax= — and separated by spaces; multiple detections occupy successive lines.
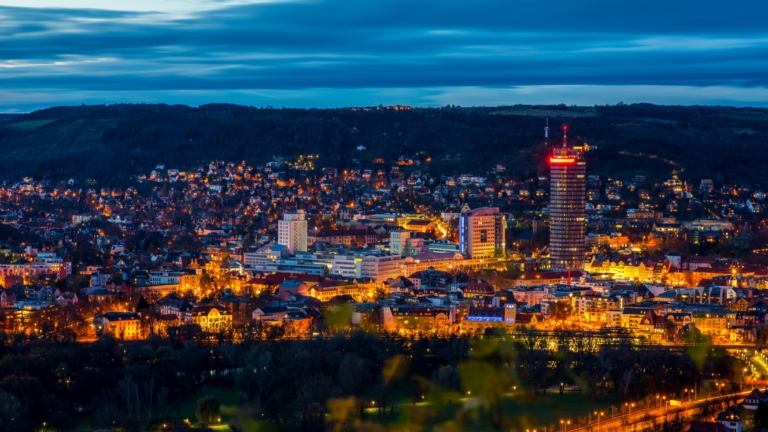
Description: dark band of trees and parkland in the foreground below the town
xmin=0 ymin=332 xmax=741 ymax=431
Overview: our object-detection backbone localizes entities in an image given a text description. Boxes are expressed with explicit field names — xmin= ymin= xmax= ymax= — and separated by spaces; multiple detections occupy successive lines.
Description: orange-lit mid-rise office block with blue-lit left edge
xmin=459 ymin=204 xmax=506 ymax=259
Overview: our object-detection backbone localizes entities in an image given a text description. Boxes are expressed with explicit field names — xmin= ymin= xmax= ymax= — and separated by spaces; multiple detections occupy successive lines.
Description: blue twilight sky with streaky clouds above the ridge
xmin=0 ymin=0 xmax=768 ymax=112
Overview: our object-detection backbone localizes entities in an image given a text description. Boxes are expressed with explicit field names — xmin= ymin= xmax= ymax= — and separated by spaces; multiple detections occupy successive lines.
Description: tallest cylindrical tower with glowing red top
xmin=549 ymin=127 xmax=586 ymax=270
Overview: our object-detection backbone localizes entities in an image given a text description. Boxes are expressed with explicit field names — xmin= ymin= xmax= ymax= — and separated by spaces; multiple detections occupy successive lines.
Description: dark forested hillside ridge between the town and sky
xmin=0 ymin=104 xmax=768 ymax=183
